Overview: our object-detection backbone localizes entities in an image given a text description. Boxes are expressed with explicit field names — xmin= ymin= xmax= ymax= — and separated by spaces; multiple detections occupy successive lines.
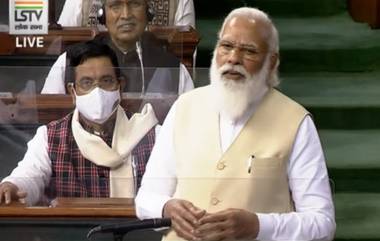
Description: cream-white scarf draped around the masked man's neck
xmin=71 ymin=104 xmax=158 ymax=197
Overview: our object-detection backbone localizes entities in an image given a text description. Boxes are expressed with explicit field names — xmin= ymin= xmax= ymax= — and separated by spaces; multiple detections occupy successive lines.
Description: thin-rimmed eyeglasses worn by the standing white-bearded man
xmin=218 ymin=40 xmax=265 ymax=61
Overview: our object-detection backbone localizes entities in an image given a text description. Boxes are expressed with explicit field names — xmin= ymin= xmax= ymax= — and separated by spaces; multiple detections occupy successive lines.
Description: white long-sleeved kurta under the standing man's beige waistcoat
xmin=136 ymin=100 xmax=335 ymax=240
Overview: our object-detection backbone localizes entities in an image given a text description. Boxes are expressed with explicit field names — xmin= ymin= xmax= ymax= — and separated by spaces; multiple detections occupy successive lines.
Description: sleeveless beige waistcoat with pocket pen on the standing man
xmin=164 ymin=86 xmax=308 ymax=240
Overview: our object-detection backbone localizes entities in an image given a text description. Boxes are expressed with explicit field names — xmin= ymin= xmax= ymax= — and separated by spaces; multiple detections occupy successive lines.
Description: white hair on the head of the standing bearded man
xmin=218 ymin=7 xmax=280 ymax=87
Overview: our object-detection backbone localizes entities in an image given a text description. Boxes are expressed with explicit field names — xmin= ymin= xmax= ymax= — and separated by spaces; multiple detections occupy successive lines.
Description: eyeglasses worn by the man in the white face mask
xmin=76 ymin=76 xmax=119 ymax=92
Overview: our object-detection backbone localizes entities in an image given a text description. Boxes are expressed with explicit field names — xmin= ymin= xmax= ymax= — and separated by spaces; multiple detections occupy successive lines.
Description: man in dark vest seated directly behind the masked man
xmin=42 ymin=0 xmax=194 ymax=94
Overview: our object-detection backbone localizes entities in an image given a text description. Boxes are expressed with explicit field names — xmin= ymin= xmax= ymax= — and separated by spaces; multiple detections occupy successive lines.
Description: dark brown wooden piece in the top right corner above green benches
xmin=347 ymin=0 xmax=380 ymax=29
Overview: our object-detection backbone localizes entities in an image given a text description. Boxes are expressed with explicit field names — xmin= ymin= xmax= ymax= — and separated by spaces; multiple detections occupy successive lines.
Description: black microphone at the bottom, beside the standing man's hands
xmin=87 ymin=218 xmax=172 ymax=239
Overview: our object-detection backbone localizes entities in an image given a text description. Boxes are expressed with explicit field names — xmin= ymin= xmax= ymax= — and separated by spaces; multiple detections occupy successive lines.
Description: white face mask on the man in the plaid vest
xmin=74 ymin=87 xmax=120 ymax=124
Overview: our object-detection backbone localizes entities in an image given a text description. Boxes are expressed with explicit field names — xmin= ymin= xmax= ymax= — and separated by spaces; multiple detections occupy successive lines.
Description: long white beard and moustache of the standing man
xmin=210 ymin=54 xmax=270 ymax=121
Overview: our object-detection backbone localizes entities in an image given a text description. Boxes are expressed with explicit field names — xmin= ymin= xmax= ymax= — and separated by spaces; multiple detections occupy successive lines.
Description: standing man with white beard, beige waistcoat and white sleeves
xmin=136 ymin=8 xmax=336 ymax=240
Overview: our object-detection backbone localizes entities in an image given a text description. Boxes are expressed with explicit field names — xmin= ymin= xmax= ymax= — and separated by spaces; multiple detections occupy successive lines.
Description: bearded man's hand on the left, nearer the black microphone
xmin=163 ymin=199 xmax=206 ymax=240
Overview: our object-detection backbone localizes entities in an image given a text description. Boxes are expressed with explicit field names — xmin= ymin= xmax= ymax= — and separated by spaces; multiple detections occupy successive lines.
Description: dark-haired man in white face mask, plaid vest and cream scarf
xmin=0 ymin=42 xmax=157 ymax=205
